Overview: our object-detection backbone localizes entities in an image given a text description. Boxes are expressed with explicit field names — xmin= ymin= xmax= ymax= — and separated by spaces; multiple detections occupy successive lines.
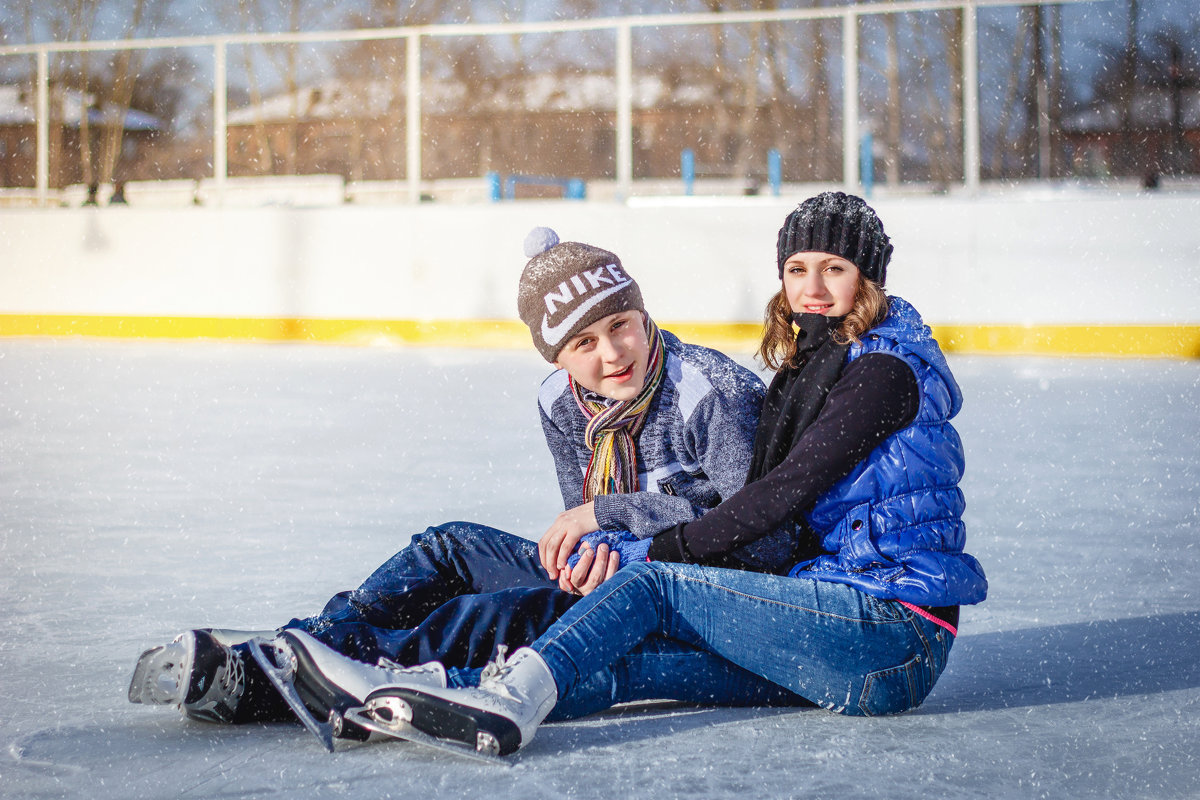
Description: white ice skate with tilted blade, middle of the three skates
xmin=250 ymin=630 xmax=446 ymax=752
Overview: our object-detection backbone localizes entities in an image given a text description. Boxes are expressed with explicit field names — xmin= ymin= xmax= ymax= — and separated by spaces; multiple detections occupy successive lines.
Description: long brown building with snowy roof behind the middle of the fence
xmin=228 ymin=72 xmax=825 ymax=187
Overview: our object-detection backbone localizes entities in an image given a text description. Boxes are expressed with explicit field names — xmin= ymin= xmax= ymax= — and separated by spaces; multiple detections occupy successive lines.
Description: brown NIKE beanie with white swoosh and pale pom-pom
xmin=517 ymin=228 xmax=646 ymax=362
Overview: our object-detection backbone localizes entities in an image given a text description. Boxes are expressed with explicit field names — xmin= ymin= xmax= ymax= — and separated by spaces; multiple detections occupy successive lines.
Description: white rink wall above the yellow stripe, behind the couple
xmin=0 ymin=191 xmax=1200 ymax=325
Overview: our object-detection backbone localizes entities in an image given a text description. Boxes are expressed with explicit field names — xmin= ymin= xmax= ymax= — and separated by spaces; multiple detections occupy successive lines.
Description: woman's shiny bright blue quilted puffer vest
xmin=790 ymin=297 xmax=988 ymax=606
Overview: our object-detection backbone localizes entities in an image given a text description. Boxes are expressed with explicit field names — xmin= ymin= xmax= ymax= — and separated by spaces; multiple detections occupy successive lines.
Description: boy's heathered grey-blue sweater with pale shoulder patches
xmin=538 ymin=331 xmax=763 ymax=551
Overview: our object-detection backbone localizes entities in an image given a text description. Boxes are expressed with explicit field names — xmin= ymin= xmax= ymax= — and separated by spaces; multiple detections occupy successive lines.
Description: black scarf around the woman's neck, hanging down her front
xmin=746 ymin=314 xmax=850 ymax=483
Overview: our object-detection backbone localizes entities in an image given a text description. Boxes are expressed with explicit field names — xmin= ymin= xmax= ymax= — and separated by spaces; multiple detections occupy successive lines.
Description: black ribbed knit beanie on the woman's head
xmin=776 ymin=192 xmax=892 ymax=287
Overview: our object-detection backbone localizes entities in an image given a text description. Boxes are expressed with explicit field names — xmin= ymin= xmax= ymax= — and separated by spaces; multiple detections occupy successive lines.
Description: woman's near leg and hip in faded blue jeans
xmin=530 ymin=561 xmax=954 ymax=716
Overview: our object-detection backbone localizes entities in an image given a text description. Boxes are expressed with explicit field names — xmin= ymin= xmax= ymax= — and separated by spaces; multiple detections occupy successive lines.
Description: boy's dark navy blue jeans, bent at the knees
xmin=283 ymin=522 xmax=578 ymax=667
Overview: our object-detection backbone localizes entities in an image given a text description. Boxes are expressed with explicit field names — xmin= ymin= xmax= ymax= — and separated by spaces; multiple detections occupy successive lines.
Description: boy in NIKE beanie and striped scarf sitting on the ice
xmin=128 ymin=228 xmax=780 ymax=722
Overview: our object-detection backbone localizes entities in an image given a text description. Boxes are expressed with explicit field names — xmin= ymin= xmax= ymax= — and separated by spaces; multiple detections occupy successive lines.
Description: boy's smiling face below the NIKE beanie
xmin=554 ymin=311 xmax=650 ymax=401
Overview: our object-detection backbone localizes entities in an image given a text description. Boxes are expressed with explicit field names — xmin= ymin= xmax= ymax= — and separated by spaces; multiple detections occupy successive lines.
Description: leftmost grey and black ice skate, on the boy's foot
xmin=130 ymin=630 xmax=254 ymax=723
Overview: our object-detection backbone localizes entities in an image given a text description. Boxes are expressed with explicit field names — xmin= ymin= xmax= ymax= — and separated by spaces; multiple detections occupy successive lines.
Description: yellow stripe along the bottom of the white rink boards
xmin=0 ymin=314 xmax=1200 ymax=359
